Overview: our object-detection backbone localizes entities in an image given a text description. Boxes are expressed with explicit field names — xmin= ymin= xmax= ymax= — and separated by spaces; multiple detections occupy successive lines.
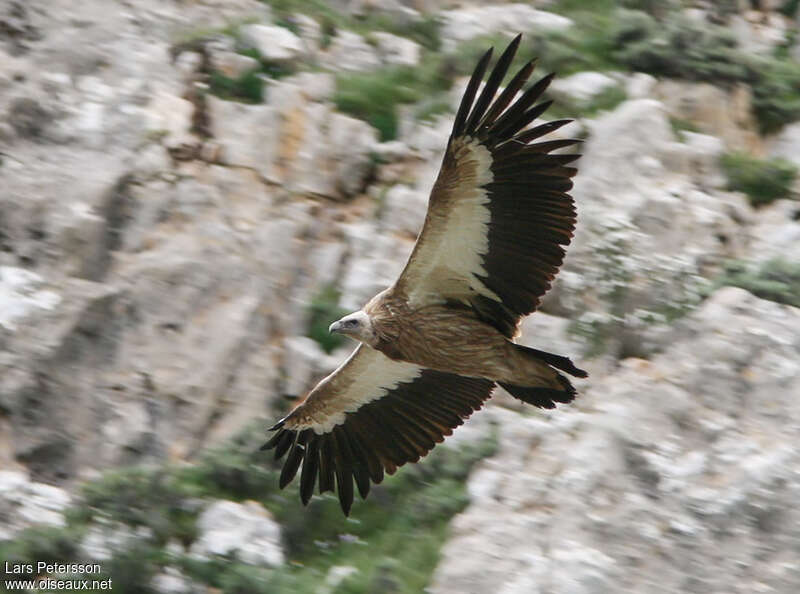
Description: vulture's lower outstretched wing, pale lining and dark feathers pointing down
xmin=262 ymin=345 xmax=494 ymax=514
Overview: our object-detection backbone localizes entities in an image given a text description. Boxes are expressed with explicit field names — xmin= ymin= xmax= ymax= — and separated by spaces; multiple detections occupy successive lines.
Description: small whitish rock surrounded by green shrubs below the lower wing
xmin=191 ymin=500 xmax=284 ymax=567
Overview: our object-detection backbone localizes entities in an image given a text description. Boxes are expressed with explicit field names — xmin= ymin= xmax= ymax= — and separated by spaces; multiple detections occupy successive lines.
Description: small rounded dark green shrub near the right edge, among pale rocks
xmin=721 ymin=153 xmax=797 ymax=206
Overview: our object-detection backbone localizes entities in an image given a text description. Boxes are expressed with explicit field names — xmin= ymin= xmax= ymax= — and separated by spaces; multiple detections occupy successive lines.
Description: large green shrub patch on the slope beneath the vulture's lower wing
xmin=0 ymin=416 xmax=497 ymax=594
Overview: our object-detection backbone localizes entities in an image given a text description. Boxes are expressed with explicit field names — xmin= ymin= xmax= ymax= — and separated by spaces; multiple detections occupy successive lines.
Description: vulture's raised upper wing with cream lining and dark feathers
xmin=395 ymin=36 xmax=579 ymax=337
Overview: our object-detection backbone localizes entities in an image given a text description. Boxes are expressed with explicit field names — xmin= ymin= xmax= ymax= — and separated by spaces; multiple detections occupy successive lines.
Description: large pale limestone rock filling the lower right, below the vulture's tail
xmin=431 ymin=288 xmax=800 ymax=594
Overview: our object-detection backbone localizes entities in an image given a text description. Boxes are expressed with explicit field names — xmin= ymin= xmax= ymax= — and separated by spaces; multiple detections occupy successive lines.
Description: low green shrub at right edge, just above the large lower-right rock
xmin=712 ymin=258 xmax=800 ymax=307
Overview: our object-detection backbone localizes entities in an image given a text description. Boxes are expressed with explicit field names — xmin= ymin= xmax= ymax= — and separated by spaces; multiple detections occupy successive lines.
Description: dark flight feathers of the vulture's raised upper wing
xmin=451 ymin=38 xmax=579 ymax=337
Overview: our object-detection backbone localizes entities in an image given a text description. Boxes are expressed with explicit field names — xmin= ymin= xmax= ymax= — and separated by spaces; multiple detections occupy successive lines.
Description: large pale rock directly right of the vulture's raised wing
xmin=545 ymin=99 xmax=749 ymax=355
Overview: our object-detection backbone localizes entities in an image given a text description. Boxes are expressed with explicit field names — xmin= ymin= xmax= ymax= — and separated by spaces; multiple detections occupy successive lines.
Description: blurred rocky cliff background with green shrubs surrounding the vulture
xmin=0 ymin=0 xmax=800 ymax=594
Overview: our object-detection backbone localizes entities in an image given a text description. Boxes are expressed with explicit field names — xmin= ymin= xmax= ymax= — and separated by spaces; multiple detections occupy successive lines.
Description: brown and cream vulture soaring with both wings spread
xmin=262 ymin=35 xmax=587 ymax=515
